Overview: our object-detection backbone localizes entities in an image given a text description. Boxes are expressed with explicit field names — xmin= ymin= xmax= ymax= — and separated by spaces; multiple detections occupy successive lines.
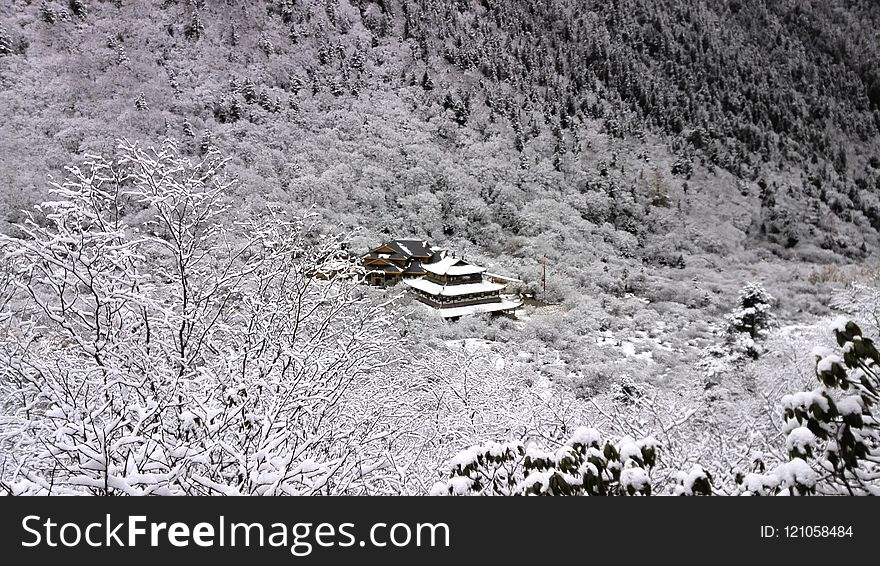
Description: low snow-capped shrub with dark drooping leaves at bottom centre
xmin=431 ymin=427 xmax=711 ymax=495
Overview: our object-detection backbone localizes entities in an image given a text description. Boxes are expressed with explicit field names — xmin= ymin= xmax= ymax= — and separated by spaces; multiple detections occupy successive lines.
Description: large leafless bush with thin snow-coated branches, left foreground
xmin=0 ymin=142 xmax=386 ymax=495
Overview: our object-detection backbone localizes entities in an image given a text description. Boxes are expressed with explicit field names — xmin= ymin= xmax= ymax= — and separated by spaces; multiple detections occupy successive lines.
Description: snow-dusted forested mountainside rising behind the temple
xmin=0 ymin=0 xmax=880 ymax=262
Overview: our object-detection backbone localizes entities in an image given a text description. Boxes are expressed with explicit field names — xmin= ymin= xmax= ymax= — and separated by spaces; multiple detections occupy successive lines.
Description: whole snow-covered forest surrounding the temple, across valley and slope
xmin=0 ymin=0 xmax=880 ymax=495
